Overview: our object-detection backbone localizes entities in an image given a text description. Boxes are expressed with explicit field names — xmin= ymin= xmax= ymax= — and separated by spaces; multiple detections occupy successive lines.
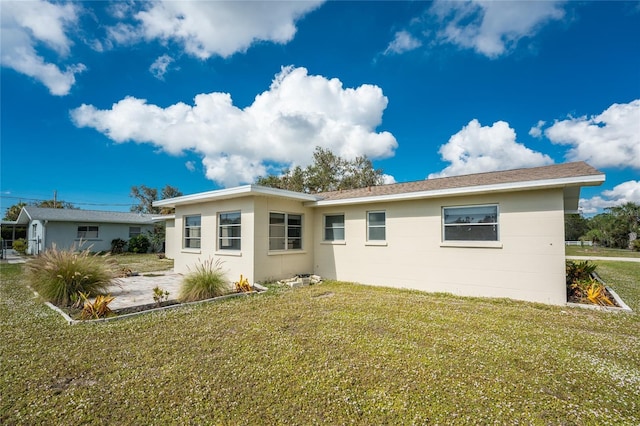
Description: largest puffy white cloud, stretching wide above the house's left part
xmin=71 ymin=67 xmax=397 ymax=186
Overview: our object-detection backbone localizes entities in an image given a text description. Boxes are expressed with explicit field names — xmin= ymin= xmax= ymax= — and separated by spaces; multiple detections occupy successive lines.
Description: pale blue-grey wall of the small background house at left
xmin=39 ymin=221 xmax=153 ymax=252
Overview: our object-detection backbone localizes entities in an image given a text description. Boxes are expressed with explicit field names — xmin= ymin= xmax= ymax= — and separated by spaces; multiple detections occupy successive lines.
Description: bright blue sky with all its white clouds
xmin=0 ymin=0 xmax=640 ymax=213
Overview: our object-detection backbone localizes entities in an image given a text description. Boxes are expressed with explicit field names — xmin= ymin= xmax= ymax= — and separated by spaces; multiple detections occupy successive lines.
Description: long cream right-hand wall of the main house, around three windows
xmin=314 ymin=189 xmax=566 ymax=304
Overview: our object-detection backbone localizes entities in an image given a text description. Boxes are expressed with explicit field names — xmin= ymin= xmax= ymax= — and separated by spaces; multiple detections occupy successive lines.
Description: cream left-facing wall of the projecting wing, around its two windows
xmin=175 ymin=197 xmax=254 ymax=282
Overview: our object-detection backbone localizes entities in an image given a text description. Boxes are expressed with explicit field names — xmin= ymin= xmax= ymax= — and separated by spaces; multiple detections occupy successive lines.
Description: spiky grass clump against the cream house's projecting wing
xmin=179 ymin=258 xmax=229 ymax=302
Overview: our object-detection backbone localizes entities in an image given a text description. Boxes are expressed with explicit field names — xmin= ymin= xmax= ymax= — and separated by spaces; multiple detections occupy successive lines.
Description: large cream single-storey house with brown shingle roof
xmin=154 ymin=162 xmax=605 ymax=304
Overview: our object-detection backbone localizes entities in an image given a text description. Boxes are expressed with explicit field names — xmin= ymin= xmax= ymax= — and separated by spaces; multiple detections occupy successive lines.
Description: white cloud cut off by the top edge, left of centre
xmin=109 ymin=0 xmax=322 ymax=59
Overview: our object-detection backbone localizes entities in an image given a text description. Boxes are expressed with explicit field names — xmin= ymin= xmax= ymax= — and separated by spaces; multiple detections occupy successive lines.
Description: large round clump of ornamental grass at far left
xmin=25 ymin=245 xmax=114 ymax=306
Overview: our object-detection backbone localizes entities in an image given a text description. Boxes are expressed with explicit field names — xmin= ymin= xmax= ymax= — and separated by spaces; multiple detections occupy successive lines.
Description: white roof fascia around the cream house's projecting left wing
xmin=153 ymin=185 xmax=319 ymax=207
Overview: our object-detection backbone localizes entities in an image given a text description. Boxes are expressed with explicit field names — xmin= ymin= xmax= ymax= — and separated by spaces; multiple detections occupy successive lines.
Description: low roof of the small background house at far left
xmin=16 ymin=206 xmax=153 ymax=224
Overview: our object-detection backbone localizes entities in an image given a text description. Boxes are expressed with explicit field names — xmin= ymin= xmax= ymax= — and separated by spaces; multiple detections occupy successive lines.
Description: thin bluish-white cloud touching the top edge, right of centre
xmin=430 ymin=0 xmax=565 ymax=58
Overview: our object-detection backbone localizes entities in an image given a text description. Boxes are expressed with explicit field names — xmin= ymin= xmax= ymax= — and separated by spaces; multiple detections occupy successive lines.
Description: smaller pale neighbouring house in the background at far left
xmin=16 ymin=206 xmax=153 ymax=254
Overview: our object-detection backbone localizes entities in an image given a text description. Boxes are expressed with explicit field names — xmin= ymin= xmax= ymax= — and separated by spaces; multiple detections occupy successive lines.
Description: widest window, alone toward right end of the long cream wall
xmin=442 ymin=205 xmax=498 ymax=241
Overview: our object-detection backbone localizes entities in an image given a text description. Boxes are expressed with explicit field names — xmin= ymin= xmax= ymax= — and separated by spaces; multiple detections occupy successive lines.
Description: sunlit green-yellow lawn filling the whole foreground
xmin=0 ymin=262 xmax=640 ymax=425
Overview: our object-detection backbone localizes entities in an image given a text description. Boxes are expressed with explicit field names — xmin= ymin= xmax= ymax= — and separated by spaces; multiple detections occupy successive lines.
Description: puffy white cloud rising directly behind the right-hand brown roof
xmin=428 ymin=119 xmax=553 ymax=179
